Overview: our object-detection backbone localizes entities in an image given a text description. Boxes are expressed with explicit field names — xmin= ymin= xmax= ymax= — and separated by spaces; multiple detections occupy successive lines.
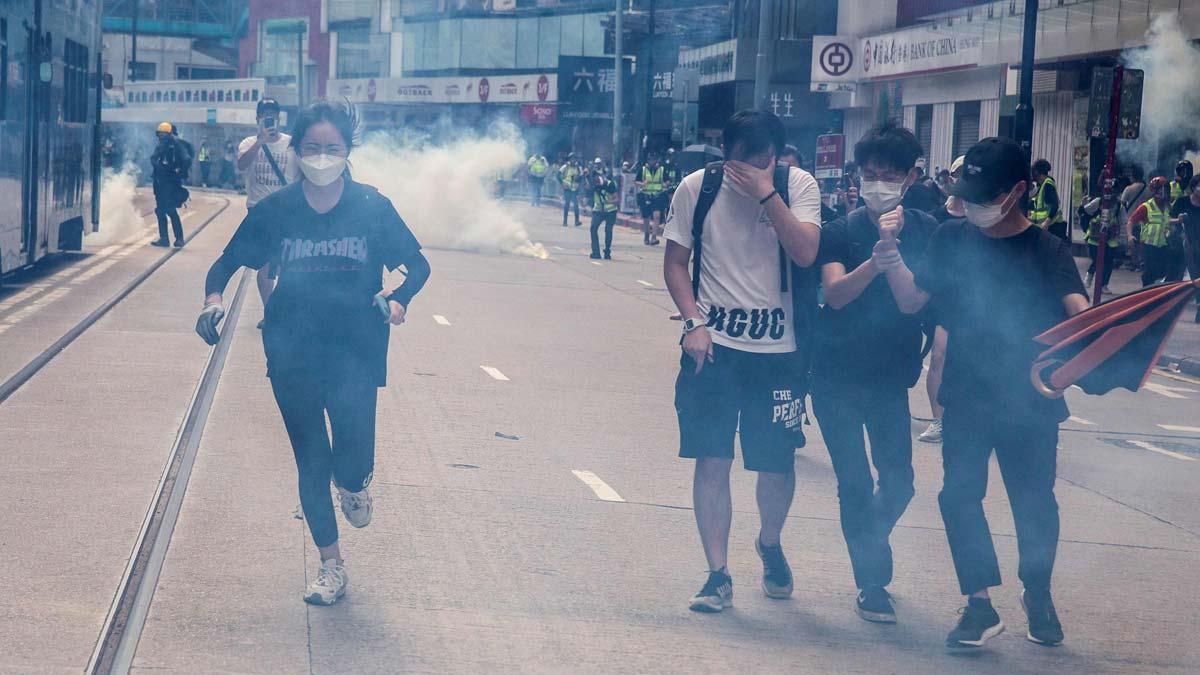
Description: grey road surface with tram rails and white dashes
xmin=0 ymin=192 xmax=1200 ymax=674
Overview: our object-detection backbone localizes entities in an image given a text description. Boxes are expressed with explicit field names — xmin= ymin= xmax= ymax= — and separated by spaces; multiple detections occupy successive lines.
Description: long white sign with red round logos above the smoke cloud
xmin=329 ymin=73 xmax=558 ymax=103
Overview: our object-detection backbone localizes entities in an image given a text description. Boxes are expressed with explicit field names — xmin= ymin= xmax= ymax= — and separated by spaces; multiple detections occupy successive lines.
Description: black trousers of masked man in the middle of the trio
xmin=812 ymin=382 xmax=913 ymax=589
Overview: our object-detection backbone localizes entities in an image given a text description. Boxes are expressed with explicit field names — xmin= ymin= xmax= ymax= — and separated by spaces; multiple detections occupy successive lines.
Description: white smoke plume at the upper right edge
xmin=1117 ymin=14 xmax=1200 ymax=172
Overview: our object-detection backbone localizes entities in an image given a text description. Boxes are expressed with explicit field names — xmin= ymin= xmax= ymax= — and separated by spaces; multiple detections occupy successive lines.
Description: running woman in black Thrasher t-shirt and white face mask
xmin=196 ymin=101 xmax=430 ymax=605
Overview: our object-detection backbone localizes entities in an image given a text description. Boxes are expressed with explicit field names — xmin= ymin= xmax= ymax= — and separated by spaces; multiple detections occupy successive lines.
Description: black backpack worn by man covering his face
xmin=691 ymin=162 xmax=821 ymax=437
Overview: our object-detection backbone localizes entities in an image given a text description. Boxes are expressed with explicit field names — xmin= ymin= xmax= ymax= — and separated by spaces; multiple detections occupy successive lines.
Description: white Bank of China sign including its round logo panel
xmin=811 ymin=28 xmax=983 ymax=91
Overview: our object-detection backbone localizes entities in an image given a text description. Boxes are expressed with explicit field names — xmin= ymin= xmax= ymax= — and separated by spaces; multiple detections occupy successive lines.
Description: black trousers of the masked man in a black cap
xmin=937 ymin=407 xmax=1058 ymax=596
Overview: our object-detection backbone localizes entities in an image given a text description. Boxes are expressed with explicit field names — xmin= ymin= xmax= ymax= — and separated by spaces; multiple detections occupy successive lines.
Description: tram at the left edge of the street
xmin=0 ymin=0 xmax=103 ymax=276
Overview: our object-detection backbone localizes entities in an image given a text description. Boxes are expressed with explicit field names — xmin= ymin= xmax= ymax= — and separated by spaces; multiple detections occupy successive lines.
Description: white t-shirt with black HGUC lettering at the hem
xmin=665 ymin=168 xmax=821 ymax=353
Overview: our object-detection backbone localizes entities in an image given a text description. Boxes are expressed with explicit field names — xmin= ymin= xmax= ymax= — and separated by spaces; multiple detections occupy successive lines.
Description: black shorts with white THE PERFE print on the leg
xmin=676 ymin=345 xmax=804 ymax=473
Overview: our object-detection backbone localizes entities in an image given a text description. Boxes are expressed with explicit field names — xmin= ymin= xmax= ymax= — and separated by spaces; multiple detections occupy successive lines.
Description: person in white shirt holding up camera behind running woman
xmin=238 ymin=98 xmax=300 ymax=329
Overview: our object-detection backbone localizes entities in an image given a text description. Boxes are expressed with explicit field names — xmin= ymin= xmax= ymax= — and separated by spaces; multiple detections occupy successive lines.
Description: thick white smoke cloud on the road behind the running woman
xmin=350 ymin=124 xmax=548 ymax=258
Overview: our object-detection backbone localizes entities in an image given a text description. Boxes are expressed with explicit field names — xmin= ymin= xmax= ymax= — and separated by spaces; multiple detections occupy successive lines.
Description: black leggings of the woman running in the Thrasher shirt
xmin=271 ymin=374 xmax=378 ymax=546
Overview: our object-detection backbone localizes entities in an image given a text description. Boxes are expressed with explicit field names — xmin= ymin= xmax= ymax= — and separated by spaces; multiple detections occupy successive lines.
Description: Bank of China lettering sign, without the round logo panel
xmin=858 ymin=28 xmax=983 ymax=79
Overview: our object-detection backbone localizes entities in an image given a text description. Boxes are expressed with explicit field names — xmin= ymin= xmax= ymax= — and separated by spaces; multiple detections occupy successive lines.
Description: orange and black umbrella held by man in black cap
xmin=1030 ymin=281 xmax=1200 ymax=399
